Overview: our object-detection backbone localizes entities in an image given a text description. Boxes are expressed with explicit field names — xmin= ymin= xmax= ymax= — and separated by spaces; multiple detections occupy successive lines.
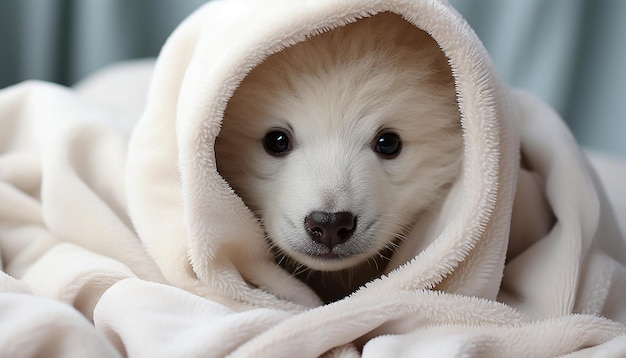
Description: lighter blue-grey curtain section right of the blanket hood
xmin=450 ymin=0 xmax=626 ymax=158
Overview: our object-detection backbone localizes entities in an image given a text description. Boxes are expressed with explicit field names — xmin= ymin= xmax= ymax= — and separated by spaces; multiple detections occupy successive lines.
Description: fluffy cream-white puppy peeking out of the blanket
xmin=215 ymin=13 xmax=462 ymax=301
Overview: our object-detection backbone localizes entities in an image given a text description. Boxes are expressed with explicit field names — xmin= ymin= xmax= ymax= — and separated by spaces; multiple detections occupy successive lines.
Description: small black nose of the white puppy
xmin=304 ymin=211 xmax=356 ymax=250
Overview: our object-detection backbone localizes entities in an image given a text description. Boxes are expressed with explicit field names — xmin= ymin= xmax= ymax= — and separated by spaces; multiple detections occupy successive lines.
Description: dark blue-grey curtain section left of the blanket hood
xmin=0 ymin=0 xmax=206 ymax=87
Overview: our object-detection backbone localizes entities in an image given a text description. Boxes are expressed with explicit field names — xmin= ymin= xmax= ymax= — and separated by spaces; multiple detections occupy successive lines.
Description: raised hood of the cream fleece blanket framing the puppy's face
xmin=126 ymin=0 xmax=624 ymax=316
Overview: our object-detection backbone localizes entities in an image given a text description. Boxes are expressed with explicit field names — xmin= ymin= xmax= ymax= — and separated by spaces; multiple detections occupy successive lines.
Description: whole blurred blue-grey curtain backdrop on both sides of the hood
xmin=0 ymin=0 xmax=626 ymax=158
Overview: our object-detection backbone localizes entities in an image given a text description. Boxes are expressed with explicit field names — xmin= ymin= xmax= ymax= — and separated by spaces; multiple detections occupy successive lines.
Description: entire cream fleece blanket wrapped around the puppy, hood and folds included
xmin=0 ymin=0 xmax=626 ymax=357
